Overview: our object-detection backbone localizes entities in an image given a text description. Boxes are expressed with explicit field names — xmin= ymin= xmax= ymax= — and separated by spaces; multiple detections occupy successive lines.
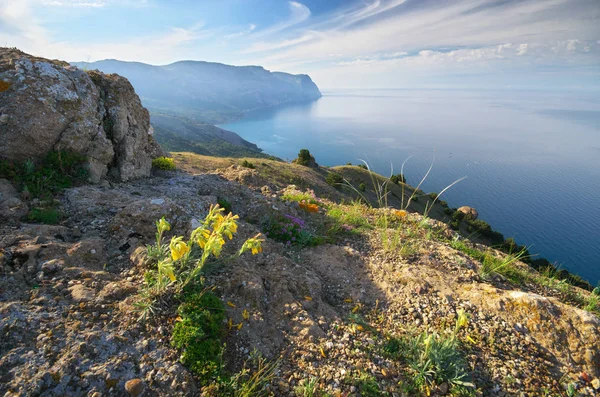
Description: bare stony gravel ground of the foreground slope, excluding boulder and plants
xmin=0 ymin=160 xmax=600 ymax=396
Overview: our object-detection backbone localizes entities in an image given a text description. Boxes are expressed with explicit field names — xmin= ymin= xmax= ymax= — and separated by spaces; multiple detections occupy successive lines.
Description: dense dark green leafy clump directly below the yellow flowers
xmin=171 ymin=290 xmax=225 ymax=386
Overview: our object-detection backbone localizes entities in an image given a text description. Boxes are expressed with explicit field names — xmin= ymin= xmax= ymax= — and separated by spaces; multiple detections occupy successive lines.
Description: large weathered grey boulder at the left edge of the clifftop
xmin=0 ymin=48 xmax=162 ymax=182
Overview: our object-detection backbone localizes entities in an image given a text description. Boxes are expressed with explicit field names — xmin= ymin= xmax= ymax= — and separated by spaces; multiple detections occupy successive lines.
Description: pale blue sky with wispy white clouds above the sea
xmin=0 ymin=0 xmax=600 ymax=90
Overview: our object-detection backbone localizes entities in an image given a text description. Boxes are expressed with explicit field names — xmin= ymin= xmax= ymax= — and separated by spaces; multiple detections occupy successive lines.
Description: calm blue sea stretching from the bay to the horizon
xmin=221 ymin=90 xmax=600 ymax=284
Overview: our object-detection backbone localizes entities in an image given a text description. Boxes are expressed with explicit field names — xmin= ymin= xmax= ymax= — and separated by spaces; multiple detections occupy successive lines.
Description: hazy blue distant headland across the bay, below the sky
xmin=72 ymin=60 xmax=321 ymax=124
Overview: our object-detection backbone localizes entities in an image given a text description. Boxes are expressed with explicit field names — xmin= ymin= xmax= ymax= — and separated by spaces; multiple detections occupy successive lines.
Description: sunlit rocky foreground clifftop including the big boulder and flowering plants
xmin=0 ymin=49 xmax=600 ymax=397
